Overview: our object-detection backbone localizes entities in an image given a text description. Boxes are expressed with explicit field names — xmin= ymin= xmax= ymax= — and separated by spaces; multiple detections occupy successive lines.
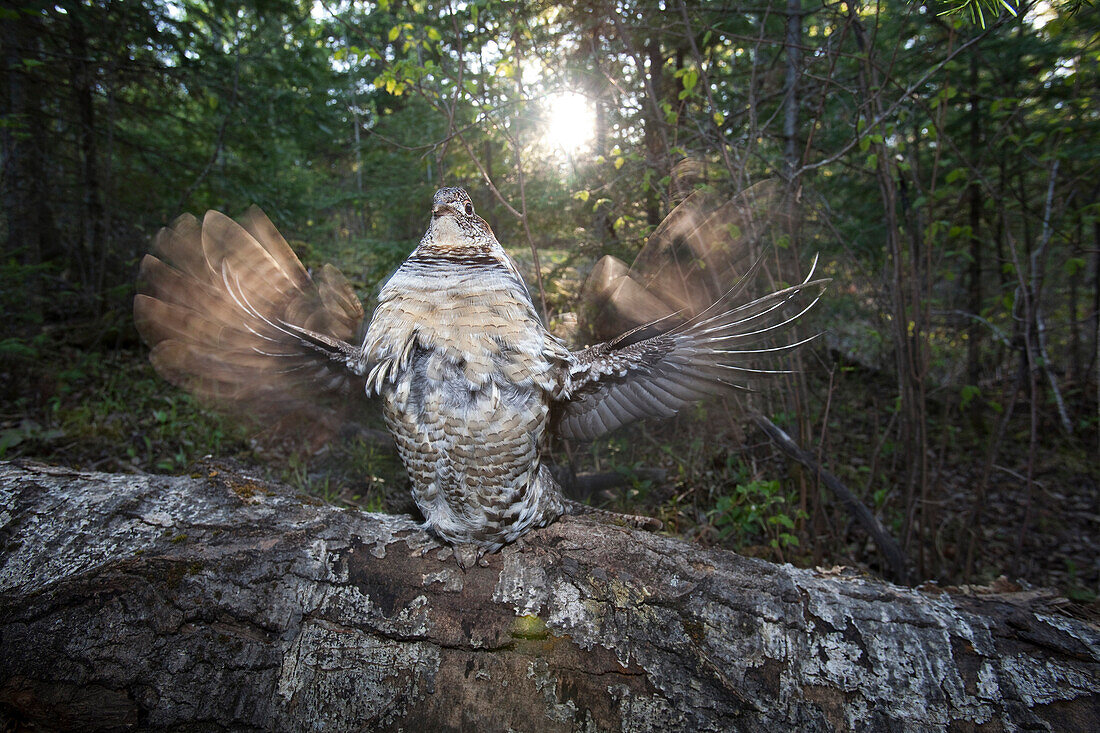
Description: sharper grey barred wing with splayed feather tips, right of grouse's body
xmin=557 ymin=260 xmax=826 ymax=440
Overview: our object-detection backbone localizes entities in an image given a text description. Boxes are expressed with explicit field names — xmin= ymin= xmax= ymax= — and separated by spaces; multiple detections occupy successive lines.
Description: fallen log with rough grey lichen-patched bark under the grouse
xmin=0 ymin=463 xmax=1100 ymax=732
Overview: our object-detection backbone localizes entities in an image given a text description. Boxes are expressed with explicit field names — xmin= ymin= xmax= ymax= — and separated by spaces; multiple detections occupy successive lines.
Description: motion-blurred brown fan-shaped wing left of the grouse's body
xmin=134 ymin=207 xmax=366 ymax=427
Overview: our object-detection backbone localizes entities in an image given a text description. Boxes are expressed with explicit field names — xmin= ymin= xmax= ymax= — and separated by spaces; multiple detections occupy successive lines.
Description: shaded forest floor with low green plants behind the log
xmin=0 ymin=342 xmax=1100 ymax=617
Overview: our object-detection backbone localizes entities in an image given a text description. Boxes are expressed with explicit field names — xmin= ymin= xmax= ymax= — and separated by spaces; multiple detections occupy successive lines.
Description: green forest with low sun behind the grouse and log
xmin=0 ymin=0 xmax=1100 ymax=603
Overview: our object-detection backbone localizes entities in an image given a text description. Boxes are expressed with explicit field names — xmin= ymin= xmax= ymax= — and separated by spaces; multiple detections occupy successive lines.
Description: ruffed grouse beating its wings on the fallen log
xmin=134 ymin=188 xmax=817 ymax=553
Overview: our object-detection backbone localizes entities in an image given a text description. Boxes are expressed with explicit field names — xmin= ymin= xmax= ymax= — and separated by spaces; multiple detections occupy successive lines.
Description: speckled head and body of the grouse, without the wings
xmin=363 ymin=188 xmax=570 ymax=551
